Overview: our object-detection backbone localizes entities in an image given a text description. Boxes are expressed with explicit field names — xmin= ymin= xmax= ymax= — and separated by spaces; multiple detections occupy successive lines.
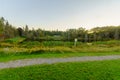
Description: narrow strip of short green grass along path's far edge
xmin=0 ymin=52 xmax=120 ymax=62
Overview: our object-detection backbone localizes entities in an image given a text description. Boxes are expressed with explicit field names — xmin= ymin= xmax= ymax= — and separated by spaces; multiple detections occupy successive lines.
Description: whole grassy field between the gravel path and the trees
xmin=0 ymin=38 xmax=120 ymax=62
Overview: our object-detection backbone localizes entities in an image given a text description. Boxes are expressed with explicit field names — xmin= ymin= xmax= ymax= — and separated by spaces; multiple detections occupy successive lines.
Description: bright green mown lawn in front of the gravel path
xmin=0 ymin=60 xmax=120 ymax=80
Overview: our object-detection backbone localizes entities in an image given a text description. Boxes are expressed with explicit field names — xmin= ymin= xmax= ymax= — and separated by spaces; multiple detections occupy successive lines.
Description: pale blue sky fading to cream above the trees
xmin=0 ymin=0 xmax=120 ymax=30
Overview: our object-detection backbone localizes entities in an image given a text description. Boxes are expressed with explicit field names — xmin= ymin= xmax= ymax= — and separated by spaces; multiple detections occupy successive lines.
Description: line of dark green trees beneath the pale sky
xmin=0 ymin=17 xmax=120 ymax=42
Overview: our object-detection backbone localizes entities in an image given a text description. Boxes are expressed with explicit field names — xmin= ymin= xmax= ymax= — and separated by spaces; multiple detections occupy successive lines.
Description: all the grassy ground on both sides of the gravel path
xmin=0 ymin=37 xmax=120 ymax=80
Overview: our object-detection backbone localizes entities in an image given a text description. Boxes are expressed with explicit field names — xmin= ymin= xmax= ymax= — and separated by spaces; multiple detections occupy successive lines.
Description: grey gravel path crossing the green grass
xmin=0 ymin=55 xmax=120 ymax=69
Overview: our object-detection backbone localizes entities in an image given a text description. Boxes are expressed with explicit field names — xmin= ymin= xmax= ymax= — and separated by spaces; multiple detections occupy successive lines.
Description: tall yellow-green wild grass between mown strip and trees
xmin=0 ymin=38 xmax=120 ymax=54
